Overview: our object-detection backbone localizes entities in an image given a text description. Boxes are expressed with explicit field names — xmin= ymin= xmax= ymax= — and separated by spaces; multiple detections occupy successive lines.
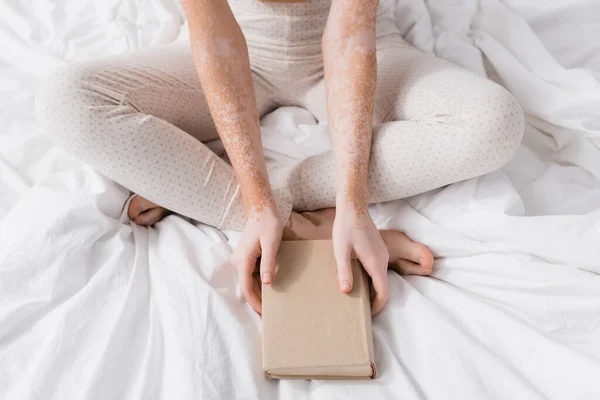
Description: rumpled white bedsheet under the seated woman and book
xmin=0 ymin=0 xmax=600 ymax=400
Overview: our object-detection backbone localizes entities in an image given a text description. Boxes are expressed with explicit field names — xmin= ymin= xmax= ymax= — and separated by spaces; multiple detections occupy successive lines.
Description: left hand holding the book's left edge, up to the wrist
xmin=230 ymin=205 xmax=283 ymax=314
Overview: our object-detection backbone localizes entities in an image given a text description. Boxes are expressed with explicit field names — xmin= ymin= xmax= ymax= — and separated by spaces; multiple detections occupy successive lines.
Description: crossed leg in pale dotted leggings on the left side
xmin=36 ymin=46 xmax=291 ymax=230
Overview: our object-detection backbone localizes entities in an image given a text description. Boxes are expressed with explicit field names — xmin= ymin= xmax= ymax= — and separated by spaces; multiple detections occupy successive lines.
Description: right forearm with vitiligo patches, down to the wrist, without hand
xmin=323 ymin=0 xmax=378 ymax=213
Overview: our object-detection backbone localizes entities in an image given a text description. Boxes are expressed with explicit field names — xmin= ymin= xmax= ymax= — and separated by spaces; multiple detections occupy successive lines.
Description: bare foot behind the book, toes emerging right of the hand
xmin=283 ymin=208 xmax=433 ymax=275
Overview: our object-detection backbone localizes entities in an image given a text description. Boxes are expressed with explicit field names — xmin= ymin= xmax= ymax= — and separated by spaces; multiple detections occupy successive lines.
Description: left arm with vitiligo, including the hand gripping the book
xmin=182 ymin=0 xmax=285 ymax=312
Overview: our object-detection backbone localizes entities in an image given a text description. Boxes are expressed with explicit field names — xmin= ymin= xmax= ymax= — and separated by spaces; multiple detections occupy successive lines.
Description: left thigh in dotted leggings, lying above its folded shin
xmin=67 ymin=44 xmax=275 ymax=141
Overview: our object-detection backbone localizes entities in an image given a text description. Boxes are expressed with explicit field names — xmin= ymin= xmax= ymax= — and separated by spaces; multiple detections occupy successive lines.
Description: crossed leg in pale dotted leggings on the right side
xmin=290 ymin=38 xmax=524 ymax=211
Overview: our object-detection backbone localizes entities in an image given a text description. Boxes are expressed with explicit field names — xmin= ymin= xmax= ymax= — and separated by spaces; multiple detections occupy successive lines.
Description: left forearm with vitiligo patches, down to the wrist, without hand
xmin=183 ymin=0 xmax=274 ymax=216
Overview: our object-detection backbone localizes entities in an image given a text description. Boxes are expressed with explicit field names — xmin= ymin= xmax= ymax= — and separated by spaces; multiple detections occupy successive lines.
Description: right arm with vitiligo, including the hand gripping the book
xmin=323 ymin=0 xmax=389 ymax=314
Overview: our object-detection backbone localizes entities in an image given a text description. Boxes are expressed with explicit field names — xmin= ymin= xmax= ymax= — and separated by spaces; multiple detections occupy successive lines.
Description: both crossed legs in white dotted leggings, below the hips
xmin=36 ymin=35 xmax=523 ymax=230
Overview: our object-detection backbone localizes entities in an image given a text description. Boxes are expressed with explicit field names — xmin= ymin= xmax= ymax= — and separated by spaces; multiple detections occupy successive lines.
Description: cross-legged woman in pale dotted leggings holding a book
xmin=37 ymin=0 xmax=523 ymax=314
